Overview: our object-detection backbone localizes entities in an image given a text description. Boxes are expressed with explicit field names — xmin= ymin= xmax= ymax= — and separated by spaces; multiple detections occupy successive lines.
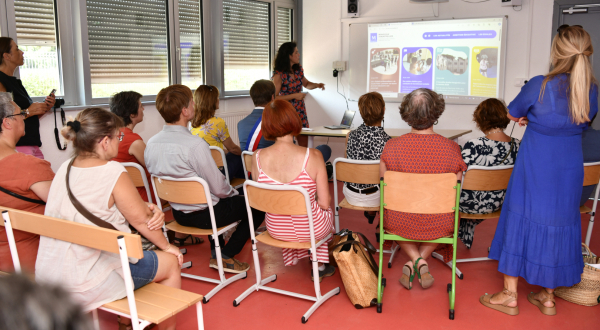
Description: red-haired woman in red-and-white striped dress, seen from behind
xmin=252 ymin=100 xmax=335 ymax=282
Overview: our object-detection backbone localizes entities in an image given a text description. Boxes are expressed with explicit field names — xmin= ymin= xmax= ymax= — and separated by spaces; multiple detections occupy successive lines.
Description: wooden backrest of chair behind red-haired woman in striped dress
xmin=244 ymin=181 xmax=310 ymax=215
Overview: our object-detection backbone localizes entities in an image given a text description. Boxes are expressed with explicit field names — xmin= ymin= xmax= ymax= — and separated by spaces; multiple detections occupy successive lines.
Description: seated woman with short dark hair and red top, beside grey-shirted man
xmin=110 ymin=91 xmax=204 ymax=247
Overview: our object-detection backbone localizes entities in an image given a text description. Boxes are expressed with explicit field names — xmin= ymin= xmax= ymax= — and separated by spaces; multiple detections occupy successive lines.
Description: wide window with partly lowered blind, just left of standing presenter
xmin=223 ymin=0 xmax=271 ymax=91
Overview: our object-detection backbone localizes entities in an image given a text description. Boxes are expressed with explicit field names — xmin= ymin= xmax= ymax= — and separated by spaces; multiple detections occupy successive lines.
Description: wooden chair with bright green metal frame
xmin=377 ymin=171 xmax=460 ymax=320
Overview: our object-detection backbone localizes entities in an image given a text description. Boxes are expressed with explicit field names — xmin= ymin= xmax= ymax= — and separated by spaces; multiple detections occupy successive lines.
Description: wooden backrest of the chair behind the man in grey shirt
xmin=152 ymin=175 xmax=210 ymax=204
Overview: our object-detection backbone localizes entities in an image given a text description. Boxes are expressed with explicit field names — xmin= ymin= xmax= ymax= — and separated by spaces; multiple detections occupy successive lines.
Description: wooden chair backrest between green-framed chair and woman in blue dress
xmin=462 ymin=165 xmax=514 ymax=191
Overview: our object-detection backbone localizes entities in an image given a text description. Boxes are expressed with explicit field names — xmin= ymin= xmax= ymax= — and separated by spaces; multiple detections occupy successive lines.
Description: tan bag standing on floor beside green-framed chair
xmin=330 ymin=229 xmax=378 ymax=309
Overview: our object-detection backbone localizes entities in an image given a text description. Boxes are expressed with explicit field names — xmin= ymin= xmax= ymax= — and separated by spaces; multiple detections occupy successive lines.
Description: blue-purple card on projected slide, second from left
xmin=400 ymin=47 xmax=433 ymax=93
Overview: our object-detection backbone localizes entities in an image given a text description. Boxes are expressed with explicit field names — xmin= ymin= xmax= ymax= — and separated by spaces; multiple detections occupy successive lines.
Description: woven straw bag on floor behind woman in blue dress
xmin=554 ymin=243 xmax=600 ymax=306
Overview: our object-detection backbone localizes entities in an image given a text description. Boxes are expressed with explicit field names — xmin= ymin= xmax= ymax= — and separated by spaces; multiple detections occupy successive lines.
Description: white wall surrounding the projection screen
xmin=301 ymin=0 xmax=553 ymax=157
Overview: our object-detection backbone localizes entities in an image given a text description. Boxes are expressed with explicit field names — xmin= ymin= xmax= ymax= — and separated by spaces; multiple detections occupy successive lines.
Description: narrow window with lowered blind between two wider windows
xmin=179 ymin=0 xmax=202 ymax=90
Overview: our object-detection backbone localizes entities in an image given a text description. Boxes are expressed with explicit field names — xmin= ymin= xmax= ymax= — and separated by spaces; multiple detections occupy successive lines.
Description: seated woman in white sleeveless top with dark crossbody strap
xmin=35 ymin=108 xmax=183 ymax=329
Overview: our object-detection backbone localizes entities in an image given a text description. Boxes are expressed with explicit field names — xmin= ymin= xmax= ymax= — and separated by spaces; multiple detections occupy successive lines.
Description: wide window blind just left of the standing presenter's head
xmin=223 ymin=0 xmax=270 ymax=67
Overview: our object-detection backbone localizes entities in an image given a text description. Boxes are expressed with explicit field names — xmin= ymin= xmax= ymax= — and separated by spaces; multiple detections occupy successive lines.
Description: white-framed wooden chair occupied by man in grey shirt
xmin=151 ymin=175 xmax=247 ymax=304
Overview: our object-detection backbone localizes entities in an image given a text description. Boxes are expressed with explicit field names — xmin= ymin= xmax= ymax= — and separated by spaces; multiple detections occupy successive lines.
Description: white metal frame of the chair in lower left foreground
xmin=2 ymin=211 xmax=204 ymax=330
